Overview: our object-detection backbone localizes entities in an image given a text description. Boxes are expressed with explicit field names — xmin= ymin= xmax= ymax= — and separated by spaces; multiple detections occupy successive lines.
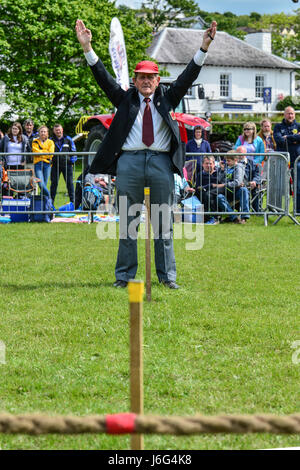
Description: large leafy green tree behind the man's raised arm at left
xmin=0 ymin=0 xmax=151 ymax=125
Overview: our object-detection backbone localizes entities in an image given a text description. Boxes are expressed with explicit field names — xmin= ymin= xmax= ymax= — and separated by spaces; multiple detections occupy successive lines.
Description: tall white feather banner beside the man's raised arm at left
xmin=109 ymin=17 xmax=129 ymax=90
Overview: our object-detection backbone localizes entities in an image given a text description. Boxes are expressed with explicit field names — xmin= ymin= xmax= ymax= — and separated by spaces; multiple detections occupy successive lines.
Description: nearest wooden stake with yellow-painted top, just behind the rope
xmin=128 ymin=281 xmax=144 ymax=450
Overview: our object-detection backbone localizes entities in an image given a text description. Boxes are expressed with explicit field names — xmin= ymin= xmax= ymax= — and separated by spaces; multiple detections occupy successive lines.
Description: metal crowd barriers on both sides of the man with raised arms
xmin=0 ymin=152 xmax=300 ymax=225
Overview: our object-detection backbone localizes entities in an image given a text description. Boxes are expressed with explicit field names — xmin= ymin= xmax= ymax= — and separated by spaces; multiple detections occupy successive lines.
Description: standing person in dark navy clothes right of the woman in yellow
xmin=50 ymin=124 xmax=77 ymax=204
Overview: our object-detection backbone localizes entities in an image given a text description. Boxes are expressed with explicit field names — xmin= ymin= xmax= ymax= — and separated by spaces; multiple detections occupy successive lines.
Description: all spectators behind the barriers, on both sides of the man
xmin=0 ymin=107 xmax=300 ymax=220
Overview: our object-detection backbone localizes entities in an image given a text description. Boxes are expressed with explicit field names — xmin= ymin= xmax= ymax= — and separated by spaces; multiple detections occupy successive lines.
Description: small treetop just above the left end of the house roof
xmin=141 ymin=0 xmax=200 ymax=32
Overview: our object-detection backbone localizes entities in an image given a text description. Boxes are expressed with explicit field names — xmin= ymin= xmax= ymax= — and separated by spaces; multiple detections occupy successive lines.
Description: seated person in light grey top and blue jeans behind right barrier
xmin=212 ymin=150 xmax=250 ymax=224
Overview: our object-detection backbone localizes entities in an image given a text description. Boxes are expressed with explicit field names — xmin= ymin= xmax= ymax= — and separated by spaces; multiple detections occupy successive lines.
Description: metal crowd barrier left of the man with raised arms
xmin=0 ymin=152 xmax=114 ymax=222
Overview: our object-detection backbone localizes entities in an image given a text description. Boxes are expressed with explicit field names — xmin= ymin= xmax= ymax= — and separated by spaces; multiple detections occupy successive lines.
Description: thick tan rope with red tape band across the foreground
xmin=0 ymin=413 xmax=300 ymax=435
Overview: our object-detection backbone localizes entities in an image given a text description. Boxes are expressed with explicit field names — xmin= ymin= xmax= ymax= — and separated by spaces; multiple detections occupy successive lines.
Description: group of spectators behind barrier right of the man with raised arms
xmin=176 ymin=107 xmax=300 ymax=225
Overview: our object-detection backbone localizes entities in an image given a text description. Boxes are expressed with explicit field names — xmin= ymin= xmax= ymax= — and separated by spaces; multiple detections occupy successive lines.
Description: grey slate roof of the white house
xmin=147 ymin=28 xmax=298 ymax=70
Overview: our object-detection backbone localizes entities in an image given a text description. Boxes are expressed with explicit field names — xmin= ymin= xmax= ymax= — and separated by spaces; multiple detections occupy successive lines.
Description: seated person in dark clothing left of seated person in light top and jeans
xmin=195 ymin=156 xmax=219 ymax=225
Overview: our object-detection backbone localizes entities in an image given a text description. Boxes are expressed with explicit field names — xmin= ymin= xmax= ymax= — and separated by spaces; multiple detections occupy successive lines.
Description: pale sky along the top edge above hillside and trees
xmin=117 ymin=0 xmax=300 ymax=15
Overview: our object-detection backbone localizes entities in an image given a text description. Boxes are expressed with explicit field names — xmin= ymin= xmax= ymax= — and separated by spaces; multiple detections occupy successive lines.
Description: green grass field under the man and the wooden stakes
xmin=0 ymin=203 xmax=300 ymax=450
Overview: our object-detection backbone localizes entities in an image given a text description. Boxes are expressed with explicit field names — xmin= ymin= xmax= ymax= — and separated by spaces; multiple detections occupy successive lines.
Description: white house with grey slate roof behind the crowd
xmin=147 ymin=28 xmax=297 ymax=113
